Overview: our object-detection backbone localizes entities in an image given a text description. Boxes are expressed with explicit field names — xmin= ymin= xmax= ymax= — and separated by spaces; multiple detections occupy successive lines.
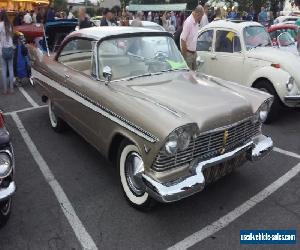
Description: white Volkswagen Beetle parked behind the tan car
xmin=197 ymin=21 xmax=300 ymax=122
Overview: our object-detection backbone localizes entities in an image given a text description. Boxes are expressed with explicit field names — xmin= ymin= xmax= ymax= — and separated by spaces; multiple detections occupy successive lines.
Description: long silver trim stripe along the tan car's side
xmin=32 ymin=69 xmax=159 ymax=143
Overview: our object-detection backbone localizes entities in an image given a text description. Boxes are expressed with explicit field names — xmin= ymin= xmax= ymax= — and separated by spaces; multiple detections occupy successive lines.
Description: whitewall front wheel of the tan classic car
xmin=117 ymin=140 xmax=155 ymax=211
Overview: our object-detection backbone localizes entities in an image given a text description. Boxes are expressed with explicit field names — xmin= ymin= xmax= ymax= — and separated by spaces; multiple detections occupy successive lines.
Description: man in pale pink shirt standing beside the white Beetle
xmin=180 ymin=5 xmax=204 ymax=70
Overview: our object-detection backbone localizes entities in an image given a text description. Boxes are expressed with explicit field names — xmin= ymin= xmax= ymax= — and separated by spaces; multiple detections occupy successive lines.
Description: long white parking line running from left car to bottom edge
xmin=11 ymin=113 xmax=98 ymax=250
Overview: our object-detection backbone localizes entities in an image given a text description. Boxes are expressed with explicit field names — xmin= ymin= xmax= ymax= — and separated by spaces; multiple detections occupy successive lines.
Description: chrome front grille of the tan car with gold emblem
xmin=152 ymin=119 xmax=261 ymax=171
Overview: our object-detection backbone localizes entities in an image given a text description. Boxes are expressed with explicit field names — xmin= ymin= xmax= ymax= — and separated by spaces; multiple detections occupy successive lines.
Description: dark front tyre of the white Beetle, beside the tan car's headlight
xmin=255 ymin=80 xmax=282 ymax=124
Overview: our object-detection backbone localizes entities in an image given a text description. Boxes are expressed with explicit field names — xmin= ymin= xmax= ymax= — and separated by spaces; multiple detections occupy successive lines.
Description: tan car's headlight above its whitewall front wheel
xmin=164 ymin=124 xmax=198 ymax=156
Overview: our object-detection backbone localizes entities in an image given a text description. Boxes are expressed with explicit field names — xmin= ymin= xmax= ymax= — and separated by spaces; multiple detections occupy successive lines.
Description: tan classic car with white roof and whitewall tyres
xmin=30 ymin=27 xmax=273 ymax=209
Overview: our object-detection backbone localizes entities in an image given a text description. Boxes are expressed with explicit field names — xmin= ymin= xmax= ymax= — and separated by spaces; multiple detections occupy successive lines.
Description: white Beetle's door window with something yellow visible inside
xmin=215 ymin=30 xmax=241 ymax=53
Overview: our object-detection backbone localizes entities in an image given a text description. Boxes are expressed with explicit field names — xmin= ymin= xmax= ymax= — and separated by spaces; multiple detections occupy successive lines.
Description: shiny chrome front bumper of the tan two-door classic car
xmin=140 ymin=135 xmax=273 ymax=202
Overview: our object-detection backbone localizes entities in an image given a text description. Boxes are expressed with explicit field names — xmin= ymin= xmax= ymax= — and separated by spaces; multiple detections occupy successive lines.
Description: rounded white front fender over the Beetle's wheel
xmin=247 ymin=66 xmax=291 ymax=102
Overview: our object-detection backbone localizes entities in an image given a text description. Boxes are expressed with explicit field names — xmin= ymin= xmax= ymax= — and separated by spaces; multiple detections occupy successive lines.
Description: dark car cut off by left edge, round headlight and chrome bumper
xmin=0 ymin=110 xmax=16 ymax=228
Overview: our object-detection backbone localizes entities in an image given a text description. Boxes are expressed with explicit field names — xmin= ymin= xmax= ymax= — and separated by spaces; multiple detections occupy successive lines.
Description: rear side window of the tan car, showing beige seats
xmin=58 ymin=39 xmax=93 ymax=76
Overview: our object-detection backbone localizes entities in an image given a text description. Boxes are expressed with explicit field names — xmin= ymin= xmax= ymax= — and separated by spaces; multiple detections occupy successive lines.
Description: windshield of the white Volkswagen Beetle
xmin=244 ymin=26 xmax=271 ymax=50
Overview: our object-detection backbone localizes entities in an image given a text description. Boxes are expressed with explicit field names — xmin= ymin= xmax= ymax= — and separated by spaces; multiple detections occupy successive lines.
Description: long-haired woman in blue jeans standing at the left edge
xmin=0 ymin=10 xmax=14 ymax=94
